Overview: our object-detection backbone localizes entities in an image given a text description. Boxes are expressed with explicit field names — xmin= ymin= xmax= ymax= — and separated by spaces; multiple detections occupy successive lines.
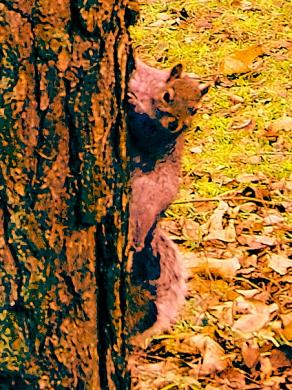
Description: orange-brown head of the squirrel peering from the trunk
xmin=152 ymin=64 xmax=210 ymax=133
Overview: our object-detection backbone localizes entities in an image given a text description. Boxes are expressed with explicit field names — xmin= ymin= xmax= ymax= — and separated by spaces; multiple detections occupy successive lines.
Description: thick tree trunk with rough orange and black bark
xmin=0 ymin=0 xmax=134 ymax=390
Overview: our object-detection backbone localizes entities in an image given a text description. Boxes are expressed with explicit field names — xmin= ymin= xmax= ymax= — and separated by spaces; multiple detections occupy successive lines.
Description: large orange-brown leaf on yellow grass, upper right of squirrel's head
xmin=220 ymin=45 xmax=264 ymax=75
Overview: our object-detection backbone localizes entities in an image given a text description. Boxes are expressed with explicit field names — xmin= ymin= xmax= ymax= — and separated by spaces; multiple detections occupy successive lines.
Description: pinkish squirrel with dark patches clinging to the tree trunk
xmin=128 ymin=60 xmax=209 ymax=344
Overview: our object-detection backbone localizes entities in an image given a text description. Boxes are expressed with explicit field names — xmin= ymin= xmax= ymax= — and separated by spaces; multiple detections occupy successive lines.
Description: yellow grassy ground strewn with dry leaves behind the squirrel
xmin=131 ymin=0 xmax=292 ymax=390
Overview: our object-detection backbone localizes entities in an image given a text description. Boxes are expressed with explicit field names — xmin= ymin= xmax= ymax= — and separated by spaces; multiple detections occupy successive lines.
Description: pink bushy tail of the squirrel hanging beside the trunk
xmin=131 ymin=227 xmax=187 ymax=345
